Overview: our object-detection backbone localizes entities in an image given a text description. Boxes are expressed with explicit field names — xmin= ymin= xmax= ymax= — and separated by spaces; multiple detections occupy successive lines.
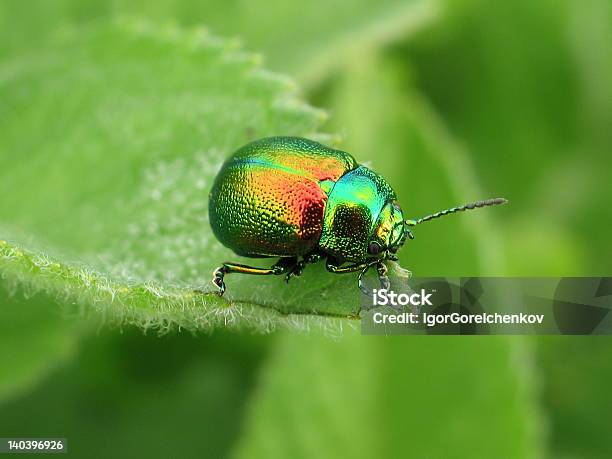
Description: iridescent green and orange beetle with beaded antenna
xmin=208 ymin=137 xmax=507 ymax=295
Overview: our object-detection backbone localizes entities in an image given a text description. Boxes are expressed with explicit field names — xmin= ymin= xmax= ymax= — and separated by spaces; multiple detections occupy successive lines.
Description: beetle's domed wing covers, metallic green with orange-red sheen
xmin=209 ymin=137 xmax=358 ymax=256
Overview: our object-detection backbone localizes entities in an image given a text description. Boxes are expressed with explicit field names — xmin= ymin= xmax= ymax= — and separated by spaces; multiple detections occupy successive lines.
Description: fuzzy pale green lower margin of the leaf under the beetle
xmin=0 ymin=240 xmax=350 ymax=336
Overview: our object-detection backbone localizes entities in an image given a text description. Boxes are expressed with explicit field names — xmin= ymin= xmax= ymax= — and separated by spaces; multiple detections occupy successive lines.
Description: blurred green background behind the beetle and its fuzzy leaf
xmin=0 ymin=0 xmax=612 ymax=458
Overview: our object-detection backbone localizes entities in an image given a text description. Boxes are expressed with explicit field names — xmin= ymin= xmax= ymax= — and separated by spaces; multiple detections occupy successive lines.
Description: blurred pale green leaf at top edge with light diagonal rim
xmin=163 ymin=0 xmax=441 ymax=87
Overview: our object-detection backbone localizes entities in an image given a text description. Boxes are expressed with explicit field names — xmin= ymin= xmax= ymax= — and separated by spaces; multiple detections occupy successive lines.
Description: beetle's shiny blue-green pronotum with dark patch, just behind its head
xmin=319 ymin=166 xmax=403 ymax=262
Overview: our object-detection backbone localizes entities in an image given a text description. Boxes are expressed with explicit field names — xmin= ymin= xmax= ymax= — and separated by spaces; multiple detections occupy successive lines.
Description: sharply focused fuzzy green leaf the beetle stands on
xmin=0 ymin=21 xmax=378 ymax=330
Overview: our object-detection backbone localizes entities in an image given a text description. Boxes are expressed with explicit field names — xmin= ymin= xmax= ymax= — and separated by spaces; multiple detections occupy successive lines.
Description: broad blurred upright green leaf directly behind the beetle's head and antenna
xmin=235 ymin=55 xmax=543 ymax=458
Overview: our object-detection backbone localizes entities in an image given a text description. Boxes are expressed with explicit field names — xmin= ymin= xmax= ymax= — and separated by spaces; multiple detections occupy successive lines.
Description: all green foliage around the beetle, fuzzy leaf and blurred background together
xmin=0 ymin=0 xmax=612 ymax=458
